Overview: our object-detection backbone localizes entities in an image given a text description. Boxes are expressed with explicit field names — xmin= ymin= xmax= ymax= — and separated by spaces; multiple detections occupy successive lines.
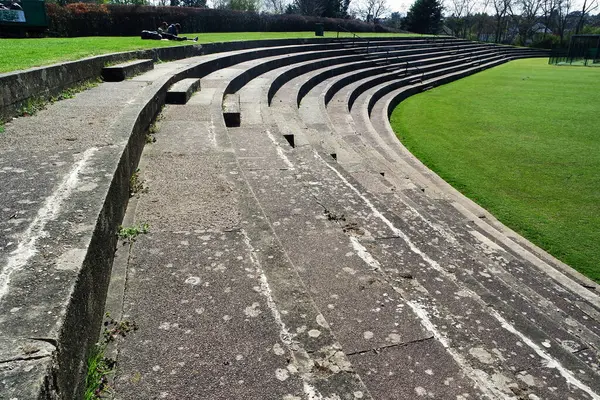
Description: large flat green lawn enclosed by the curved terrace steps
xmin=391 ymin=59 xmax=600 ymax=282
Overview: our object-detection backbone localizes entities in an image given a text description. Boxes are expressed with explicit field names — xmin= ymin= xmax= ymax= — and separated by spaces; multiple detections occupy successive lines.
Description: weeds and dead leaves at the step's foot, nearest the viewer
xmin=83 ymin=313 xmax=138 ymax=400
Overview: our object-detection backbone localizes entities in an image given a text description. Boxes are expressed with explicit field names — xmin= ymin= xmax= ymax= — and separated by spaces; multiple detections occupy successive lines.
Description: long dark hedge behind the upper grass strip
xmin=46 ymin=3 xmax=387 ymax=37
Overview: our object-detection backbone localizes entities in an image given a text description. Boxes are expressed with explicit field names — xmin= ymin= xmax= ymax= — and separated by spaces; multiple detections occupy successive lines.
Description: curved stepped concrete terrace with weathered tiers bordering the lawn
xmin=0 ymin=39 xmax=600 ymax=400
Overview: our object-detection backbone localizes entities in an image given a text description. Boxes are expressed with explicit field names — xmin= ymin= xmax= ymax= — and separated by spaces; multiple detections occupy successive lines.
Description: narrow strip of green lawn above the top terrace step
xmin=0 ymin=32 xmax=426 ymax=73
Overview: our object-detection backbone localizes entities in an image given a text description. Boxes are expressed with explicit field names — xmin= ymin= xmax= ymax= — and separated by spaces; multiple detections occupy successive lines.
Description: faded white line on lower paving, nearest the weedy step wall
xmin=241 ymin=230 xmax=323 ymax=400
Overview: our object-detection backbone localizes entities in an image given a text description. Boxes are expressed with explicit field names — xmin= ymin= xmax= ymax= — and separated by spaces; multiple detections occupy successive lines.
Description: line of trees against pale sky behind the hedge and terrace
xmin=48 ymin=0 xmax=600 ymax=47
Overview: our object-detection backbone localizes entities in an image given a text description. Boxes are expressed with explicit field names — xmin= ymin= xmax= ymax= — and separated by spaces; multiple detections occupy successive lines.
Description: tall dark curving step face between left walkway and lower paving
xmin=38 ymin=64 xmax=180 ymax=399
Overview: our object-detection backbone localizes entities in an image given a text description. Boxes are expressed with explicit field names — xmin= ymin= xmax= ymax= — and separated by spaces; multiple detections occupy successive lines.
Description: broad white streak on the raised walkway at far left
xmin=0 ymin=147 xmax=98 ymax=300
